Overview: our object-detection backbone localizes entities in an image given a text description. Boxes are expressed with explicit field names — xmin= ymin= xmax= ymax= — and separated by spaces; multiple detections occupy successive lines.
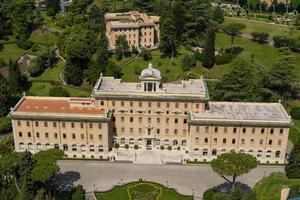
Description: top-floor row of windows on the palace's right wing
xmin=196 ymin=126 xmax=283 ymax=134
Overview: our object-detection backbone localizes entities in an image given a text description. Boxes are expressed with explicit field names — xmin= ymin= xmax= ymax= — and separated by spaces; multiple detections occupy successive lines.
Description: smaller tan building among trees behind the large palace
xmin=104 ymin=11 xmax=160 ymax=49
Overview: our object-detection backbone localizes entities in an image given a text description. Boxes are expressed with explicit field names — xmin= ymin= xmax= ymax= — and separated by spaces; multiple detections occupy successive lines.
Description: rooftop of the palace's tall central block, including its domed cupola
xmin=92 ymin=63 xmax=208 ymax=100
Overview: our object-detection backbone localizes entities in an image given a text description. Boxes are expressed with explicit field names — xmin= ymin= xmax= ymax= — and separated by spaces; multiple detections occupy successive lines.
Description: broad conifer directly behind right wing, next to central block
xmin=212 ymin=59 xmax=261 ymax=101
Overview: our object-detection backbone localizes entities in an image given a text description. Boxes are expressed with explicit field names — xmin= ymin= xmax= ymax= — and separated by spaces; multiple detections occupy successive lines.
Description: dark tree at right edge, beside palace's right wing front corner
xmin=285 ymin=144 xmax=300 ymax=179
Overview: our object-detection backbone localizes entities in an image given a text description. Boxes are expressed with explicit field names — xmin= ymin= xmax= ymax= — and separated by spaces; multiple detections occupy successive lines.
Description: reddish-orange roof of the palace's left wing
xmin=16 ymin=97 xmax=105 ymax=115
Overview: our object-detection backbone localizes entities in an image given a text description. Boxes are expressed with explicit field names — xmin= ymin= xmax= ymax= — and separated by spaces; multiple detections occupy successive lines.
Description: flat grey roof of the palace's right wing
xmin=192 ymin=102 xmax=291 ymax=122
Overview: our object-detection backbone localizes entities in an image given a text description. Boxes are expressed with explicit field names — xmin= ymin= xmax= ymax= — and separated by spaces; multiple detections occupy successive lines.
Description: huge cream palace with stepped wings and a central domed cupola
xmin=10 ymin=63 xmax=291 ymax=163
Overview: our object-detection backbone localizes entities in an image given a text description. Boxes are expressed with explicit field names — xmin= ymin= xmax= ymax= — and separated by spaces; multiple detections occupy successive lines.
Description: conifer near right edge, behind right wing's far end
xmin=263 ymin=49 xmax=297 ymax=99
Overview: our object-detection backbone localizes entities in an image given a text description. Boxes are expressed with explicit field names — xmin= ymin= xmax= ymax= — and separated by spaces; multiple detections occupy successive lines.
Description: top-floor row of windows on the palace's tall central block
xmin=107 ymin=101 xmax=200 ymax=108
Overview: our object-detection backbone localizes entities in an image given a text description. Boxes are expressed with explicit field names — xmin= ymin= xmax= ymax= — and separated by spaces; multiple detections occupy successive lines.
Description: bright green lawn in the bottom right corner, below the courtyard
xmin=253 ymin=173 xmax=300 ymax=200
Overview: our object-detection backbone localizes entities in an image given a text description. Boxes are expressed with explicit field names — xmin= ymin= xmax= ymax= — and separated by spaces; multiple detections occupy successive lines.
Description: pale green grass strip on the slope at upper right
xmin=224 ymin=17 xmax=300 ymax=38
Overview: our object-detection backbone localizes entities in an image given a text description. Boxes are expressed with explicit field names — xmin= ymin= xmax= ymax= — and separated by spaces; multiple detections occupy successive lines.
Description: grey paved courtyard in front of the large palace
xmin=58 ymin=160 xmax=284 ymax=197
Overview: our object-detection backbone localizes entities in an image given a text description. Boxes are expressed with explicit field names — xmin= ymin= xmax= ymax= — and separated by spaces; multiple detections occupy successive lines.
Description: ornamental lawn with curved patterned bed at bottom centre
xmin=95 ymin=182 xmax=193 ymax=200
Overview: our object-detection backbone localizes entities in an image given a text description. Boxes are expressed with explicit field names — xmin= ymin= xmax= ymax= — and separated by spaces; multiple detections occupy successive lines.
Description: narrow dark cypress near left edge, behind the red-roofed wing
xmin=8 ymin=60 xmax=23 ymax=94
